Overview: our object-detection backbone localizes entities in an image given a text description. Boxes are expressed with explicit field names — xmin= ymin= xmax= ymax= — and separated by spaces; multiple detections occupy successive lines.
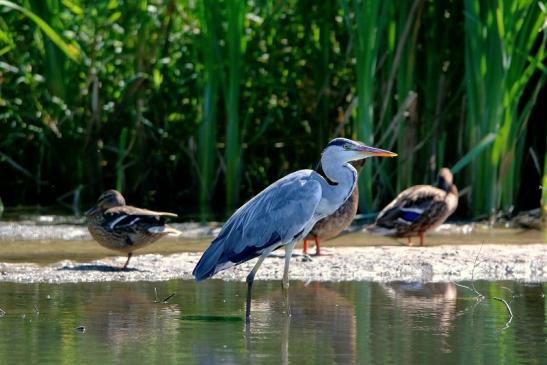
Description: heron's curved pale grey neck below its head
xmin=319 ymin=157 xmax=357 ymax=215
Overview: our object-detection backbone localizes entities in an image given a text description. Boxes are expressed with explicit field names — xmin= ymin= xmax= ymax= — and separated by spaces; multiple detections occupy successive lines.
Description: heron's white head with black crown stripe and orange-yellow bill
xmin=323 ymin=138 xmax=397 ymax=162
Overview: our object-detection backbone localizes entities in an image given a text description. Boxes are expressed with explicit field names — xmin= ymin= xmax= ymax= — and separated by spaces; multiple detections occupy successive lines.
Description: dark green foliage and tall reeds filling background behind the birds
xmin=0 ymin=0 xmax=547 ymax=219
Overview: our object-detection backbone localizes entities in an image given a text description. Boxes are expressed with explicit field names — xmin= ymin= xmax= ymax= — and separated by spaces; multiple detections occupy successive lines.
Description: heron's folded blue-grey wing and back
xmin=193 ymin=170 xmax=321 ymax=280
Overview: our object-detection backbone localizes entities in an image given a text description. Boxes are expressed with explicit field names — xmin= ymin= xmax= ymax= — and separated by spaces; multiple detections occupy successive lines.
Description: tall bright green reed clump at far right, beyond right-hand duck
xmin=465 ymin=0 xmax=545 ymax=216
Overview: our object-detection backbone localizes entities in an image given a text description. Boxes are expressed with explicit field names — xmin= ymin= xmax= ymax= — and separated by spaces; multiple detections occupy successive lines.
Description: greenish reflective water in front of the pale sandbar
xmin=0 ymin=280 xmax=547 ymax=364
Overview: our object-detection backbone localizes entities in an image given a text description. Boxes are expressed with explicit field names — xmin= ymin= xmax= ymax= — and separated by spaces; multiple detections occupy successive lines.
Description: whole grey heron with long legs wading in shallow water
xmin=192 ymin=138 xmax=397 ymax=322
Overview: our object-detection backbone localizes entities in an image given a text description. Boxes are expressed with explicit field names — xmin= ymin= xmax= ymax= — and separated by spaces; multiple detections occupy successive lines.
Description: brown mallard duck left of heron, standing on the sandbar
xmin=85 ymin=190 xmax=181 ymax=270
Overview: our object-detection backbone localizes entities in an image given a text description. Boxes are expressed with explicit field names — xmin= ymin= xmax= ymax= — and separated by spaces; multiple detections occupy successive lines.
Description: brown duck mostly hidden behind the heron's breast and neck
xmin=302 ymin=160 xmax=366 ymax=256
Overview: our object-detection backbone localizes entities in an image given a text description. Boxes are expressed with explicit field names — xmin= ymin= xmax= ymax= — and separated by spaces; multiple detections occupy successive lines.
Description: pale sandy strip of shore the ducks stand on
xmin=0 ymin=244 xmax=547 ymax=283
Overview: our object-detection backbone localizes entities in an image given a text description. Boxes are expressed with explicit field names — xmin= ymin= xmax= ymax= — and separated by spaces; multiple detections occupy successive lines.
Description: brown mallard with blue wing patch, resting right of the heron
xmin=367 ymin=168 xmax=458 ymax=246
